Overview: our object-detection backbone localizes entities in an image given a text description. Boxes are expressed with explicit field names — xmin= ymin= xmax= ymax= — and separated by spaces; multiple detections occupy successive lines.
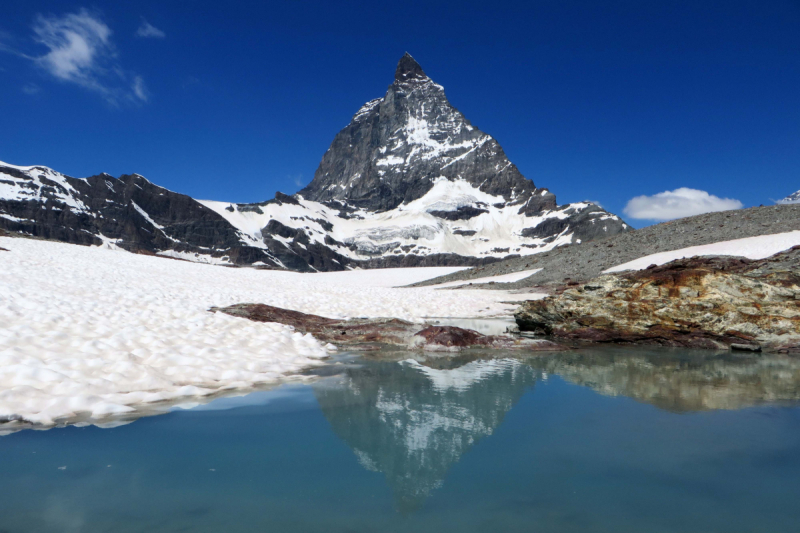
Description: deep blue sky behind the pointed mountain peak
xmin=0 ymin=0 xmax=800 ymax=226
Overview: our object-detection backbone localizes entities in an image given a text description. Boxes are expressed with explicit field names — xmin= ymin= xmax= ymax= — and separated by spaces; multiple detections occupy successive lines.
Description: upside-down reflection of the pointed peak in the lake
xmin=315 ymin=359 xmax=536 ymax=511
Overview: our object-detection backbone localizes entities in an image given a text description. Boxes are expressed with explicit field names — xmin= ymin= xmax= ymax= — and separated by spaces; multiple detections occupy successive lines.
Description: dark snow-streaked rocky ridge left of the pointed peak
xmin=0 ymin=165 xmax=270 ymax=263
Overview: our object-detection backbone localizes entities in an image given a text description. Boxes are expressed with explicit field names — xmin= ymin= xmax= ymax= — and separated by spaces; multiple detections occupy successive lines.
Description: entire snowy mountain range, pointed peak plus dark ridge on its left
xmin=0 ymin=54 xmax=629 ymax=271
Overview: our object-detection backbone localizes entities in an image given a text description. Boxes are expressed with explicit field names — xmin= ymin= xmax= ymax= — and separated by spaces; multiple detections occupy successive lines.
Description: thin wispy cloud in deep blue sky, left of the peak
xmin=26 ymin=9 xmax=147 ymax=105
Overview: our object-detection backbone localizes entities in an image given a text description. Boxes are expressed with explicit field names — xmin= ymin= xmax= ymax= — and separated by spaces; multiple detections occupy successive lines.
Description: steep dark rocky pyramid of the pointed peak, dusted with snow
xmin=299 ymin=54 xmax=544 ymax=211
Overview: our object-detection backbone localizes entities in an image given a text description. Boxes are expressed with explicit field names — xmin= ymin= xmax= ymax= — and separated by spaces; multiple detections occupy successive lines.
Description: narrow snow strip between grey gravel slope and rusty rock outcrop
xmin=603 ymin=231 xmax=800 ymax=274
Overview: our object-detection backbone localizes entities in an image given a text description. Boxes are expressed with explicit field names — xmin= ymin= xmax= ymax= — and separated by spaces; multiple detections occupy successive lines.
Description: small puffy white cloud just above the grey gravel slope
xmin=623 ymin=187 xmax=743 ymax=221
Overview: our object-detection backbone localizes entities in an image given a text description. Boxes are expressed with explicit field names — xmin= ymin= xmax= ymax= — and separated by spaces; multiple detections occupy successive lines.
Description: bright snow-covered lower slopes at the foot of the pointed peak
xmin=200 ymin=178 xmax=618 ymax=260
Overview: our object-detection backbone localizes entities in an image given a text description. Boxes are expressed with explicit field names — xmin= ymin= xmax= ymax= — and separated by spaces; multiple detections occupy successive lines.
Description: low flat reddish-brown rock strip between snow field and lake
xmin=210 ymin=304 xmax=563 ymax=351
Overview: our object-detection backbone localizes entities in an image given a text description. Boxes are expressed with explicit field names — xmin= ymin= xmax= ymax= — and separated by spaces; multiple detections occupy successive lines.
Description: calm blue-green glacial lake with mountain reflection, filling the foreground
xmin=0 ymin=348 xmax=800 ymax=533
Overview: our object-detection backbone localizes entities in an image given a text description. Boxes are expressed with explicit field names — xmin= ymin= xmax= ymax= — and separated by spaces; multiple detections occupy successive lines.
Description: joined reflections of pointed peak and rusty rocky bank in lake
xmin=314 ymin=348 xmax=800 ymax=512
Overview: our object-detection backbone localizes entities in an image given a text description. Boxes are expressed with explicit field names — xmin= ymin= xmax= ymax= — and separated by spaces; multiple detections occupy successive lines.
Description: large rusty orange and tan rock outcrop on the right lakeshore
xmin=515 ymin=247 xmax=800 ymax=352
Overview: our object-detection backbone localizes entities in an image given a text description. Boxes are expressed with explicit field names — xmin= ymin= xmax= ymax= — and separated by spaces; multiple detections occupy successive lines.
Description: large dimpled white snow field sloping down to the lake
xmin=0 ymin=238 xmax=512 ymax=425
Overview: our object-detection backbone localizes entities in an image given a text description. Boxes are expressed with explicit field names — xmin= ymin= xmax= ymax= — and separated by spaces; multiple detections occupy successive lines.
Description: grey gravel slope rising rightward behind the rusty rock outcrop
xmin=412 ymin=204 xmax=800 ymax=290
